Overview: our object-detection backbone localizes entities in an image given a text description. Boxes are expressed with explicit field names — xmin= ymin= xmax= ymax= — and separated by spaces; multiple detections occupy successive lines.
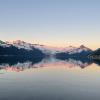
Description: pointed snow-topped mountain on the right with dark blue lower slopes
xmin=56 ymin=45 xmax=92 ymax=59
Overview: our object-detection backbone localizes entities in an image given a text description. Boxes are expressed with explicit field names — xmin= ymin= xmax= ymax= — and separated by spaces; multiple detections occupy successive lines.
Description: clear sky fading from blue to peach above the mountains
xmin=0 ymin=0 xmax=100 ymax=49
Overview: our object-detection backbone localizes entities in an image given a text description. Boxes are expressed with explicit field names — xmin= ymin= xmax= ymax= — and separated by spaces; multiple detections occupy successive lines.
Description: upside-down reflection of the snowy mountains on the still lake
xmin=0 ymin=57 xmax=100 ymax=72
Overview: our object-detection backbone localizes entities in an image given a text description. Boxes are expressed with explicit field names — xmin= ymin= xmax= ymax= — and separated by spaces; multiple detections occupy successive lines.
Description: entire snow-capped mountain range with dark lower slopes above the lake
xmin=0 ymin=40 xmax=100 ymax=59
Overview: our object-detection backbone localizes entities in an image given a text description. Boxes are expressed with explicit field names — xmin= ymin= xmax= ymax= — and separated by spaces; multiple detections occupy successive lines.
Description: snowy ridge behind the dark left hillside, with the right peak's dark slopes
xmin=0 ymin=40 xmax=99 ymax=58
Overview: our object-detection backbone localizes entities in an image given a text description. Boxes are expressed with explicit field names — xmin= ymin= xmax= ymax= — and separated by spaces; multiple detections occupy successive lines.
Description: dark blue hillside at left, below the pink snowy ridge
xmin=0 ymin=41 xmax=45 ymax=58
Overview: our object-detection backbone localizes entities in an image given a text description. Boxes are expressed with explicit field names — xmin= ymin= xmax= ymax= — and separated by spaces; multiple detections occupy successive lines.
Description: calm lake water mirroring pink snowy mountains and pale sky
xmin=0 ymin=58 xmax=100 ymax=100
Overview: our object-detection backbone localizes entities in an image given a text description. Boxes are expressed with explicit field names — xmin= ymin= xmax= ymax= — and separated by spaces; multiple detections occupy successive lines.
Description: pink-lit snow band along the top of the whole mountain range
xmin=0 ymin=40 xmax=92 ymax=55
